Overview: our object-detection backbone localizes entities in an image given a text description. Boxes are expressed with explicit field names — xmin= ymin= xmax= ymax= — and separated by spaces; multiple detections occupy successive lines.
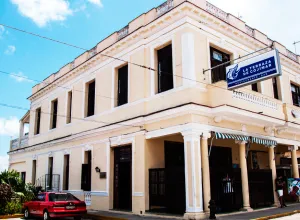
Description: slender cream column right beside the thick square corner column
xmin=201 ymin=132 xmax=211 ymax=213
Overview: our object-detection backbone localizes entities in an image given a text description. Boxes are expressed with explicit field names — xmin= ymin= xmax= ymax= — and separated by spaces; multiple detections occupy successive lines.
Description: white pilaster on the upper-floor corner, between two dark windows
xmin=181 ymin=33 xmax=196 ymax=86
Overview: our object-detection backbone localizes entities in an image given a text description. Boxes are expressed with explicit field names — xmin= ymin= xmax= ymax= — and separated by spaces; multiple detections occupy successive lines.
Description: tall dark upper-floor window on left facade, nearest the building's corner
xmin=157 ymin=44 xmax=173 ymax=93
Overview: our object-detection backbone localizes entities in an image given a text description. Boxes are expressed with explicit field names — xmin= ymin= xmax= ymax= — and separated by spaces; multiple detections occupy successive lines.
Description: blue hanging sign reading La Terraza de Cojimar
xmin=226 ymin=49 xmax=281 ymax=89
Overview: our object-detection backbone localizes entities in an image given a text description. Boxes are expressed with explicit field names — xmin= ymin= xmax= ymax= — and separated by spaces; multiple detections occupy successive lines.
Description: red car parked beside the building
xmin=23 ymin=192 xmax=86 ymax=220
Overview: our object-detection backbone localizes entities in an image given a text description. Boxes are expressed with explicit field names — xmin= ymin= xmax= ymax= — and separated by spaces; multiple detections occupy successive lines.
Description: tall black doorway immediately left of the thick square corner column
xmin=165 ymin=142 xmax=186 ymax=214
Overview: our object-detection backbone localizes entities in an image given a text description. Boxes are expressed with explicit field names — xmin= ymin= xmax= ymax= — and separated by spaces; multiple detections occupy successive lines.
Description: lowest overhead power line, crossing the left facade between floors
xmin=0 ymin=103 xmax=142 ymax=129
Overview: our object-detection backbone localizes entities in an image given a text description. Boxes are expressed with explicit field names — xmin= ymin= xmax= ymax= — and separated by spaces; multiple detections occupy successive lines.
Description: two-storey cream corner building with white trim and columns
xmin=9 ymin=0 xmax=300 ymax=219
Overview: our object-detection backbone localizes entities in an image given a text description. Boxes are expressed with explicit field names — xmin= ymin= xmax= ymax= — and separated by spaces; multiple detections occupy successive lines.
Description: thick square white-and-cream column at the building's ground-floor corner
xmin=182 ymin=129 xmax=206 ymax=219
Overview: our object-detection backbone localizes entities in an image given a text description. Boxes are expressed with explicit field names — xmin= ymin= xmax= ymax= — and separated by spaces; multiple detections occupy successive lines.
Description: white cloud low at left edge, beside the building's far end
xmin=0 ymin=116 xmax=19 ymax=137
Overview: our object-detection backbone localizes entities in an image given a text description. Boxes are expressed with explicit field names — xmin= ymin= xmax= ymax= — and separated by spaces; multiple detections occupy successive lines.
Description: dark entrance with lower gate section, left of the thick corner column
xmin=149 ymin=141 xmax=186 ymax=214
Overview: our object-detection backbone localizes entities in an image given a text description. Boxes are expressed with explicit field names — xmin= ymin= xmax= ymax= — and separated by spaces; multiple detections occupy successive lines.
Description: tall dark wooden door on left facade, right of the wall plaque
xmin=114 ymin=146 xmax=132 ymax=211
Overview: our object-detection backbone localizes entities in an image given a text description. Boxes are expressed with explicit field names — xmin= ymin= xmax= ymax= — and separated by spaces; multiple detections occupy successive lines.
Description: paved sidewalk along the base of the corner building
xmin=86 ymin=203 xmax=300 ymax=220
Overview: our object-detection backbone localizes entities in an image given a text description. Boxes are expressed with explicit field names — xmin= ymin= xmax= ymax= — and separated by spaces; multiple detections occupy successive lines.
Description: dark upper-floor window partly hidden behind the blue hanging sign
xmin=210 ymin=47 xmax=230 ymax=83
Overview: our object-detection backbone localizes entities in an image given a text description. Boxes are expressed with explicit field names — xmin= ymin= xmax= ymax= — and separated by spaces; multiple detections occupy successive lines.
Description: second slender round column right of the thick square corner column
xmin=238 ymin=141 xmax=253 ymax=212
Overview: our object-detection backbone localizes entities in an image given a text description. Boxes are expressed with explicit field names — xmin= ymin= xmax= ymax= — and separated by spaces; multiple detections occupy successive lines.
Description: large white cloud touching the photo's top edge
xmin=11 ymin=0 xmax=73 ymax=27
